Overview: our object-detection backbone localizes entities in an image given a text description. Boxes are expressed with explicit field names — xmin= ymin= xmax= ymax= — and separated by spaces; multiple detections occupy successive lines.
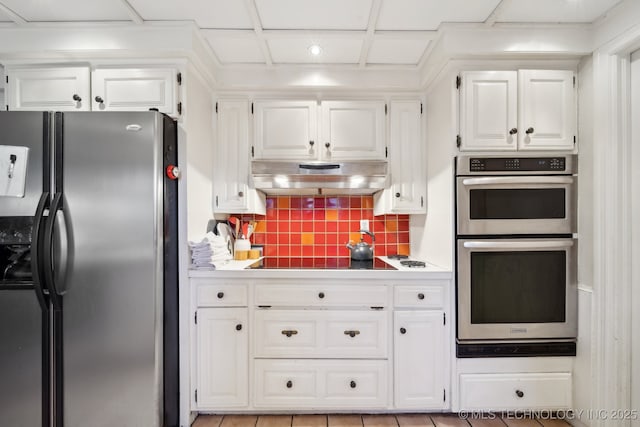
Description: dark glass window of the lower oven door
xmin=471 ymin=251 xmax=567 ymax=324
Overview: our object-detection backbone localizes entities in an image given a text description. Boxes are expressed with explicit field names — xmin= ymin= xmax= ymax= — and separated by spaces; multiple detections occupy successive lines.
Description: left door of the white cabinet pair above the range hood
xmin=253 ymin=101 xmax=320 ymax=160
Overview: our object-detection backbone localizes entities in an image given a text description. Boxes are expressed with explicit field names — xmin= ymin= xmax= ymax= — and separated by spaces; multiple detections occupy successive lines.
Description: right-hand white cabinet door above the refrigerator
xmin=91 ymin=68 xmax=177 ymax=115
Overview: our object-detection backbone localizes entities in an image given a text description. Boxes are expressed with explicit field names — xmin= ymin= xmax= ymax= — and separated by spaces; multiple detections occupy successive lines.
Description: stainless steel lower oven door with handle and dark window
xmin=457 ymin=238 xmax=577 ymax=341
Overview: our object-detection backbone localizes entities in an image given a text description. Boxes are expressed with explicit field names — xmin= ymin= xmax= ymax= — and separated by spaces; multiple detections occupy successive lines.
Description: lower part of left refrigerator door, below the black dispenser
xmin=0 ymin=290 xmax=43 ymax=427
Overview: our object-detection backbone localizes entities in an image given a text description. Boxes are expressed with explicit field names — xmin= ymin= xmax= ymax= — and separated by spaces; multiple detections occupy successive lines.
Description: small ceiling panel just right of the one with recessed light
xmin=367 ymin=37 xmax=430 ymax=65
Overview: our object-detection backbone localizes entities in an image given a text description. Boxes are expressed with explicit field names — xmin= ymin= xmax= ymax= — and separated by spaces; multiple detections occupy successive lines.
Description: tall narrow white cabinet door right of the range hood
xmin=389 ymin=101 xmax=427 ymax=214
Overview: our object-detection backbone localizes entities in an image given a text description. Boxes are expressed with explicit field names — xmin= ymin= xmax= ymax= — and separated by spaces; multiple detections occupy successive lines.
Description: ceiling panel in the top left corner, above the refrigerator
xmin=2 ymin=0 xmax=131 ymax=22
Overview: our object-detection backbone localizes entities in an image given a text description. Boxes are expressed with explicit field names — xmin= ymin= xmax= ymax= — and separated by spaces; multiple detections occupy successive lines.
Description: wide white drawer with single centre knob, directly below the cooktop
xmin=255 ymin=284 xmax=388 ymax=307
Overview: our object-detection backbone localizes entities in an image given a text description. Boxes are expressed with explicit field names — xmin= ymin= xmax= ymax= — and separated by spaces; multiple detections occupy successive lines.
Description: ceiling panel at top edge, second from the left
xmin=128 ymin=0 xmax=253 ymax=29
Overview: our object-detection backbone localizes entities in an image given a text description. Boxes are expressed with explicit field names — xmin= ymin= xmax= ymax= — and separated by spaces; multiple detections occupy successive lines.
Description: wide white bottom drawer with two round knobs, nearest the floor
xmin=255 ymin=359 xmax=387 ymax=409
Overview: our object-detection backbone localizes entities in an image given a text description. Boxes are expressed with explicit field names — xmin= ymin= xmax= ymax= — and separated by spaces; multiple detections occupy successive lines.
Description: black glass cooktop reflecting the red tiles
xmin=260 ymin=257 xmax=396 ymax=270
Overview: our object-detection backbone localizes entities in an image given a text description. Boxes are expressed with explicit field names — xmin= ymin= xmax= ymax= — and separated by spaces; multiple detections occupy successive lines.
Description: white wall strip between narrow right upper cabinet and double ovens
xmin=409 ymin=72 xmax=457 ymax=269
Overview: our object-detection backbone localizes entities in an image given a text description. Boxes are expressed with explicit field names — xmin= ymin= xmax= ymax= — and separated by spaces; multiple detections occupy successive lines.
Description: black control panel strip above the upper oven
xmin=469 ymin=157 xmax=566 ymax=172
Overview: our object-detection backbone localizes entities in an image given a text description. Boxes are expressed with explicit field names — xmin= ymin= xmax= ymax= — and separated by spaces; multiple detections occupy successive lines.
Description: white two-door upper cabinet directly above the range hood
xmin=253 ymin=100 xmax=386 ymax=161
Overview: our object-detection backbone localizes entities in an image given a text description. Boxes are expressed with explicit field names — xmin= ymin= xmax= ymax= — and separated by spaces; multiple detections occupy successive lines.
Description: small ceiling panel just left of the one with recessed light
xmin=203 ymin=30 xmax=266 ymax=64
